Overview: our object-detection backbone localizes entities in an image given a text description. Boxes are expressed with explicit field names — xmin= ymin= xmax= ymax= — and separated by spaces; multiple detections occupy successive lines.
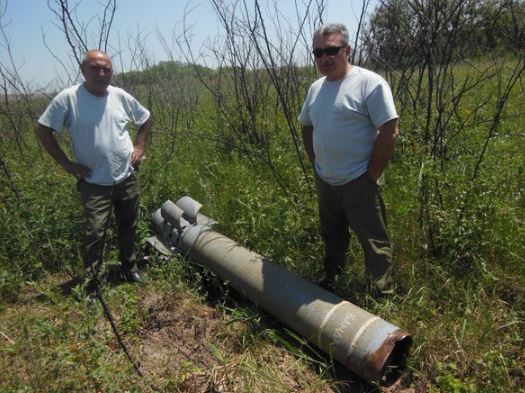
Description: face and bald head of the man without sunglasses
xmin=81 ymin=52 xmax=113 ymax=96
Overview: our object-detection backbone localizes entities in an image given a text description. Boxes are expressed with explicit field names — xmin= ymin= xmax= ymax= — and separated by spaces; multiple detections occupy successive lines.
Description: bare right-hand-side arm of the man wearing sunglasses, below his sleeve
xmin=368 ymin=119 xmax=399 ymax=181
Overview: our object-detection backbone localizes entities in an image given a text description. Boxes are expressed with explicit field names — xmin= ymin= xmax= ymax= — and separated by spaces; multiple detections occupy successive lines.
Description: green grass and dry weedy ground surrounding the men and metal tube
xmin=0 ymin=56 xmax=525 ymax=393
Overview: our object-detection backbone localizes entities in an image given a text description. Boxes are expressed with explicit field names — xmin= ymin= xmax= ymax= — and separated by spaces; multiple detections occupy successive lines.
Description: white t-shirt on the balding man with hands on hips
xmin=38 ymin=84 xmax=150 ymax=185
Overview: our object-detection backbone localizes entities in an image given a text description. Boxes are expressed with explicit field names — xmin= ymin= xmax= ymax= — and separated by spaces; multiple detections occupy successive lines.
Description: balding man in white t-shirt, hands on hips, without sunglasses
xmin=36 ymin=50 xmax=152 ymax=288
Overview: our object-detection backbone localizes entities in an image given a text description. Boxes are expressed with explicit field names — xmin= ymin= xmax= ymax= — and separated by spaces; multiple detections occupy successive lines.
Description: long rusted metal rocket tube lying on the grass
xmin=147 ymin=197 xmax=412 ymax=386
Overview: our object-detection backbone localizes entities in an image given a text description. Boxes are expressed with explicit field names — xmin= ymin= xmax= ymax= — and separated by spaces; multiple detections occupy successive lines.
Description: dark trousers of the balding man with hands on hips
xmin=77 ymin=173 xmax=140 ymax=269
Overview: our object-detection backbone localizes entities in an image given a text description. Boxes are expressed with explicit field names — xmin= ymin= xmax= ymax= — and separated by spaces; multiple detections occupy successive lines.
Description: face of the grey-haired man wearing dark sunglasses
xmin=313 ymin=33 xmax=350 ymax=81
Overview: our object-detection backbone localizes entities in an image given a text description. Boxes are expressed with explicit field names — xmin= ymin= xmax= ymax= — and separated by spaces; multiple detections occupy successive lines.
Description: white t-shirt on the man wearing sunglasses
xmin=299 ymin=65 xmax=398 ymax=185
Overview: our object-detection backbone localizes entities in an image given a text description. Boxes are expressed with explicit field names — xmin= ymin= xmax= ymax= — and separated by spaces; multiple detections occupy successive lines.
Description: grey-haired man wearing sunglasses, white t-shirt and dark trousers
xmin=299 ymin=24 xmax=399 ymax=293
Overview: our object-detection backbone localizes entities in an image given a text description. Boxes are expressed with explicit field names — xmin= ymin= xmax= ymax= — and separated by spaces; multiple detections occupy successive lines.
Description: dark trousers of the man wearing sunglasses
xmin=316 ymin=174 xmax=392 ymax=290
